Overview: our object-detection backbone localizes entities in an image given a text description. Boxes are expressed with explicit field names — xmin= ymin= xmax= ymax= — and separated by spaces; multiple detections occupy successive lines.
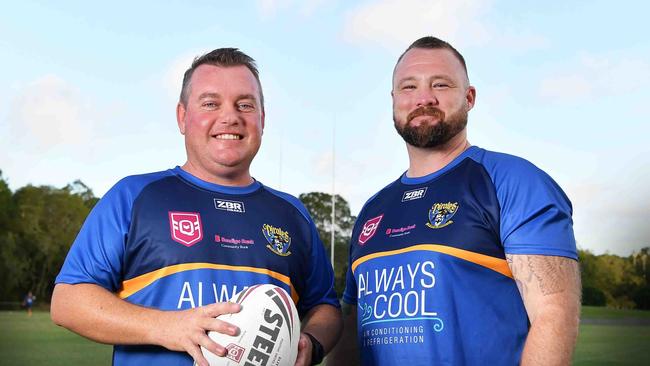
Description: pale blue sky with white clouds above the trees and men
xmin=0 ymin=0 xmax=650 ymax=255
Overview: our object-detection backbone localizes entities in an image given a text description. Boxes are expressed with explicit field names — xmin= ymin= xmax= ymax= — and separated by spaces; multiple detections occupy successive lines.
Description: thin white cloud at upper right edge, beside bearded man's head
xmin=539 ymin=55 xmax=650 ymax=102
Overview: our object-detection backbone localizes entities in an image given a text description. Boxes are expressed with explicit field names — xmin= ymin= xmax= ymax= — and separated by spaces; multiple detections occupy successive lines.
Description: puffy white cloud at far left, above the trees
xmin=8 ymin=75 xmax=93 ymax=149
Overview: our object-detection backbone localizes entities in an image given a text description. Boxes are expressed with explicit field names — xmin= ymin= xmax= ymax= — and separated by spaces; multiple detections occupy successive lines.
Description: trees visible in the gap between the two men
xmin=299 ymin=192 xmax=355 ymax=296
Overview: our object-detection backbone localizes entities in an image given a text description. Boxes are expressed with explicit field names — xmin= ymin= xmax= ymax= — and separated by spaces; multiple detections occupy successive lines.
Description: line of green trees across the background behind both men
xmin=0 ymin=171 xmax=650 ymax=309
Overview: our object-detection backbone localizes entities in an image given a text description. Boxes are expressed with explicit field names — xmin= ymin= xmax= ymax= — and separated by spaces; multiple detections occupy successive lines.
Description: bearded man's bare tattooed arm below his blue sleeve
xmin=506 ymin=254 xmax=581 ymax=366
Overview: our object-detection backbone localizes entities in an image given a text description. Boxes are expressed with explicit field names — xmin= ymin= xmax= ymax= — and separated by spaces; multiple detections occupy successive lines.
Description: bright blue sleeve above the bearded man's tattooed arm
xmin=488 ymin=154 xmax=578 ymax=259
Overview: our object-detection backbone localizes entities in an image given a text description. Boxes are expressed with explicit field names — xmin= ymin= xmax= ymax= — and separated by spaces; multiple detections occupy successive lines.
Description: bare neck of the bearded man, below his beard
xmin=406 ymin=130 xmax=471 ymax=178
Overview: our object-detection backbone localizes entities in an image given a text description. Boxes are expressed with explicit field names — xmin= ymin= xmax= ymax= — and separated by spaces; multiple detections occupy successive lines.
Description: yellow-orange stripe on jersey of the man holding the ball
xmin=117 ymin=263 xmax=299 ymax=303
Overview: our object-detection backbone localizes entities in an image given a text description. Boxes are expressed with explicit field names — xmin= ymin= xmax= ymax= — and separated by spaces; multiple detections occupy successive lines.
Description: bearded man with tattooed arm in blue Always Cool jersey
xmin=330 ymin=37 xmax=580 ymax=365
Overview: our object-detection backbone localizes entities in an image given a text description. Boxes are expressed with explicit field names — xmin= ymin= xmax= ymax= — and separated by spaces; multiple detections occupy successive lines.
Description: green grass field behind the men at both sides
xmin=0 ymin=307 xmax=650 ymax=366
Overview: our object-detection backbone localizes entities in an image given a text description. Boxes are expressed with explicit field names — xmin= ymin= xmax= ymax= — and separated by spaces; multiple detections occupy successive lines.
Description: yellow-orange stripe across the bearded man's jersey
xmin=352 ymin=244 xmax=512 ymax=278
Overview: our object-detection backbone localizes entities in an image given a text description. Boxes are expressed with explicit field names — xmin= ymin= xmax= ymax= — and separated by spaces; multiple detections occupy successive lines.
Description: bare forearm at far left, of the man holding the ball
xmin=51 ymin=284 xmax=164 ymax=344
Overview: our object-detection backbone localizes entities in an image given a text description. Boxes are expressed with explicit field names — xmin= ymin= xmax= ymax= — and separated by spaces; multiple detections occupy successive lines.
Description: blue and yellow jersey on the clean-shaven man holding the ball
xmin=56 ymin=167 xmax=339 ymax=366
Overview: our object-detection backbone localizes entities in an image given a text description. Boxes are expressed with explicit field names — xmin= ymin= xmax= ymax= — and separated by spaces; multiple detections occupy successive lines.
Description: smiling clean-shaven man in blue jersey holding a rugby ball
xmin=51 ymin=48 xmax=342 ymax=366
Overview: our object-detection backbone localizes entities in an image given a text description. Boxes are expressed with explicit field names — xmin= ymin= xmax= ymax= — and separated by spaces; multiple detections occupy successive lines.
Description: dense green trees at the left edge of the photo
xmin=0 ymin=177 xmax=96 ymax=301
